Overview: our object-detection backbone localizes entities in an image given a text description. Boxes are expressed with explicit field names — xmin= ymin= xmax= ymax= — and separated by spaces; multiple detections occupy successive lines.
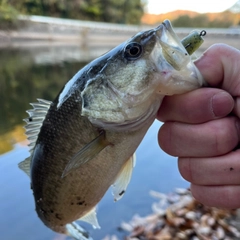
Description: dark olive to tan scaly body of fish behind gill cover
xmin=31 ymin=92 xmax=148 ymax=232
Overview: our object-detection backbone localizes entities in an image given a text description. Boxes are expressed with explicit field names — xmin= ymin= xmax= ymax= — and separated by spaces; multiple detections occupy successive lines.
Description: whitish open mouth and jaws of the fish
xmin=151 ymin=20 xmax=203 ymax=95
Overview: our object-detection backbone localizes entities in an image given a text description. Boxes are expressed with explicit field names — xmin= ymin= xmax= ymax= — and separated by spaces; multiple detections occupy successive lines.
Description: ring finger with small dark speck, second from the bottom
xmin=178 ymin=150 xmax=240 ymax=185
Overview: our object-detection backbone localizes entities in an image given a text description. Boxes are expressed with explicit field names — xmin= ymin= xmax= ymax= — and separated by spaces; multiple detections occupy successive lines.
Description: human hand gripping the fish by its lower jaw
xmin=157 ymin=44 xmax=240 ymax=209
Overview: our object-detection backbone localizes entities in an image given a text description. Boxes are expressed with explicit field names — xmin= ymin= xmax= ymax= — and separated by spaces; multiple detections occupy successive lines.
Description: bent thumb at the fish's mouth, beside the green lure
xmin=195 ymin=44 xmax=240 ymax=96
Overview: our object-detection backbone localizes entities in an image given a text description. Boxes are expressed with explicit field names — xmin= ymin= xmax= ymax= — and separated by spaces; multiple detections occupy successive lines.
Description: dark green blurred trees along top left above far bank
xmin=8 ymin=0 xmax=144 ymax=24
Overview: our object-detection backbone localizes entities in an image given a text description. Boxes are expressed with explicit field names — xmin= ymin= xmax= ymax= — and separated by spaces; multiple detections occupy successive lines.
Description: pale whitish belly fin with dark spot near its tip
xmin=112 ymin=153 xmax=136 ymax=201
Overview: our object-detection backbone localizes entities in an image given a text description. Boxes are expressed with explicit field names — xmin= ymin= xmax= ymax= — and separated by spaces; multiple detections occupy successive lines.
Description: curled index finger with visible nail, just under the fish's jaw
xmin=157 ymin=88 xmax=234 ymax=123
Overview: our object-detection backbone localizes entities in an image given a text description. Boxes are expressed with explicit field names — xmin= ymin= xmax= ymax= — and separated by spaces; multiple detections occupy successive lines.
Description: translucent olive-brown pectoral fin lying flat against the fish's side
xmin=62 ymin=131 xmax=110 ymax=177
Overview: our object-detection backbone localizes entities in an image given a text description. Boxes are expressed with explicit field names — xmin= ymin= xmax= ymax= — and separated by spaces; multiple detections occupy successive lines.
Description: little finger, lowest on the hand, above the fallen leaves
xmin=191 ymin=184 xmax=240 ymax=209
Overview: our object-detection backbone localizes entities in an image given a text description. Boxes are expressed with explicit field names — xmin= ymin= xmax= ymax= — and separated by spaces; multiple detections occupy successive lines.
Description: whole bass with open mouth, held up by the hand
xmin=19 ymin=20 xmax=204 ymax=240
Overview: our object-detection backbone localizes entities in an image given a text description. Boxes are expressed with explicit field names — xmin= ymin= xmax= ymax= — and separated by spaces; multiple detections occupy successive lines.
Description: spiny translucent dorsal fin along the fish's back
xmin=18 ymin=98 xmax=52 ymax=176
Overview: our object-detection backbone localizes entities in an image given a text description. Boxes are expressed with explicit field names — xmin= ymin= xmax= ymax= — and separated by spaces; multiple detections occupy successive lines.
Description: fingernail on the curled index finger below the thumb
xmin=212 ymin=92 xmax=234 ymax=117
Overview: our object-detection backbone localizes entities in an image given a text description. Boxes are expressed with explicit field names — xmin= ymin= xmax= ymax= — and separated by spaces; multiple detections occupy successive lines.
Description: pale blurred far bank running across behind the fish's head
xmin=0 ymin=30 xmax=240 ymax=51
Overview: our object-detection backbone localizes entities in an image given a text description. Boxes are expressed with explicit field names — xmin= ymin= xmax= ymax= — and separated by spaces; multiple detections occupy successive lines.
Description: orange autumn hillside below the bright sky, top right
xmin=172 ymin=14 xmax=233 ymax=28
